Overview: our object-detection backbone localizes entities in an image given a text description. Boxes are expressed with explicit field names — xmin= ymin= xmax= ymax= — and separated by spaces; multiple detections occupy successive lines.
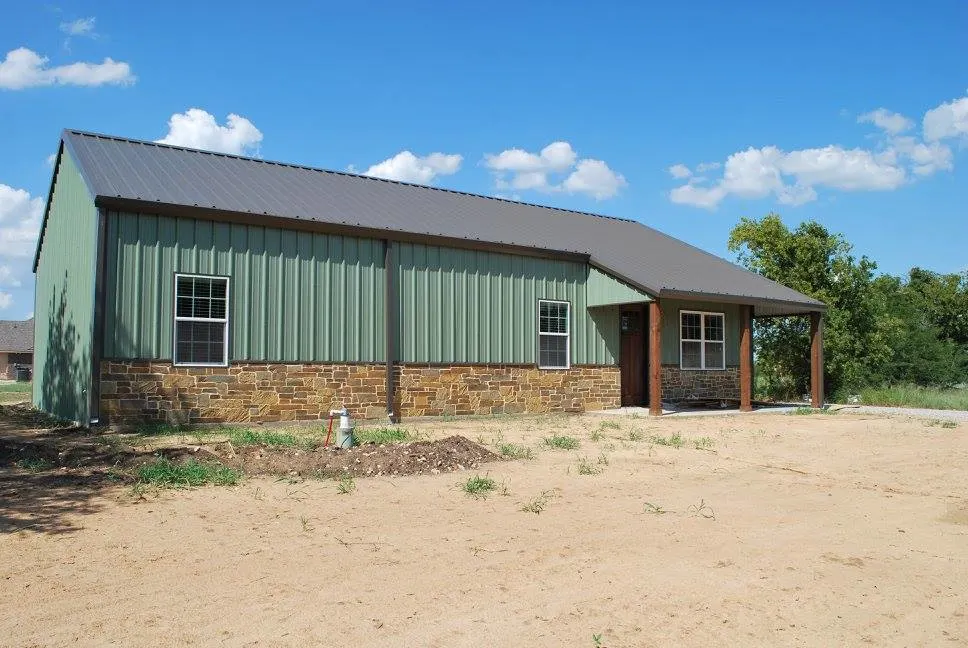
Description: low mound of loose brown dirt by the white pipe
xmin=224 ymin=436 xmax=500 ymax=477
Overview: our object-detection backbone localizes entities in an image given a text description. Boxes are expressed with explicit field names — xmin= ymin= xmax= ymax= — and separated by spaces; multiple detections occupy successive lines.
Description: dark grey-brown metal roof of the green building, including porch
xmin=38 ymin=130 xmax=824 ymax=315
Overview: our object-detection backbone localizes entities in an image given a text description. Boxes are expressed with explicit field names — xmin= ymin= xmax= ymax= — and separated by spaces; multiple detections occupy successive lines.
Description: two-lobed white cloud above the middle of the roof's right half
xmin=484 ymin=141 xmax=628 ymax=200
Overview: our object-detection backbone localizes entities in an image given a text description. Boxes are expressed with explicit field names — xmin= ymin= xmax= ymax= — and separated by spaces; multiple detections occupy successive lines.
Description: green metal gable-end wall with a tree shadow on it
xmin=33 ymin=150 xmax=97 ymax=424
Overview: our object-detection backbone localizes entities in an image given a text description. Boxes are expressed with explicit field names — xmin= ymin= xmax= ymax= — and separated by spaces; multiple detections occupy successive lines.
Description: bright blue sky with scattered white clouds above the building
xmin=0 ymin=0 xmax=968 ymax=318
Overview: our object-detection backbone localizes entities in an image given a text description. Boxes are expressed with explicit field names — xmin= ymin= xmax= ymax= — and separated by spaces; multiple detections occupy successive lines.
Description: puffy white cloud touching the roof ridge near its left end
xmin=155 ymin=108 xmax=262 ymax=155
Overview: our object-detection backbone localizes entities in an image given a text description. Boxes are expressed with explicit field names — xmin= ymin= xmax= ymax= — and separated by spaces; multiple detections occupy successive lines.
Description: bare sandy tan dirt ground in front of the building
xmin=0 ymin=413 xmax=968 ymax=648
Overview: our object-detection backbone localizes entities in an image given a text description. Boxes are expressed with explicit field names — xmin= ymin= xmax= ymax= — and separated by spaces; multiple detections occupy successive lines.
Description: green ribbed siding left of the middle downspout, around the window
xmin=104 ymin=212 xmax=386 ymax=362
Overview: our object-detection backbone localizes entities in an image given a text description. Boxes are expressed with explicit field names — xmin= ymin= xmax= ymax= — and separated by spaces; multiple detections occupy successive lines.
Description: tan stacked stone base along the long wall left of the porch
xmin=101 ymin=361 xmax=621 ymax=424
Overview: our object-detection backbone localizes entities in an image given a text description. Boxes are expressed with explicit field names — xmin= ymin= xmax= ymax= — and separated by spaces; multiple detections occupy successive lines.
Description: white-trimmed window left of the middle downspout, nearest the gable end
xmin=173 ymin=274 xmax=229 ymax=367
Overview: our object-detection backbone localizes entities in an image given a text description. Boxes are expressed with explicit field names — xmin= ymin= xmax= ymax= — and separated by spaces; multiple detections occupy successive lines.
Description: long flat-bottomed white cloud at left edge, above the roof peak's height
xmin=0 ymin=47 xmax=136 ymax=90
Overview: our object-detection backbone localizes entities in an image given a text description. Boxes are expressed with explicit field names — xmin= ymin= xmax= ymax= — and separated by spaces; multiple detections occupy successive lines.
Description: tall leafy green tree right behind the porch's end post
xmin=729 ymin=213 xmax=897 ymax=398
